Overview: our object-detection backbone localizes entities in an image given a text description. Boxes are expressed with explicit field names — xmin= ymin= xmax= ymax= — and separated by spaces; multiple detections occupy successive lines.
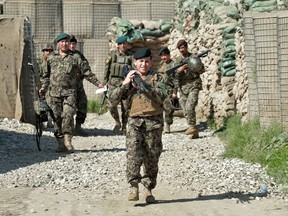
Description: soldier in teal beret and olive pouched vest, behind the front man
xmin=104 ymin=36 xmax=132 ymax=133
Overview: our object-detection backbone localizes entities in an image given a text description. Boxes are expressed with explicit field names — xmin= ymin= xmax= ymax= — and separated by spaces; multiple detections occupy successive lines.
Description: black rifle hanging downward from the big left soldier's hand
xmin=28 ymin=63 xmax=55 ymax=151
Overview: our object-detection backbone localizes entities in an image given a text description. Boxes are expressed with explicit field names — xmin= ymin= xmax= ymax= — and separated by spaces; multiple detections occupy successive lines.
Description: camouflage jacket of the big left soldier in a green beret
xmin=41 ymin=51 xmax=100 ymax=97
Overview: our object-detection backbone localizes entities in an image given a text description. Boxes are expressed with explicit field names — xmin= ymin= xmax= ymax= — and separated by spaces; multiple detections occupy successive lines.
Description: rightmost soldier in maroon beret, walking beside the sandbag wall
xmin=175 ymin=39 xmax=204 ymax=139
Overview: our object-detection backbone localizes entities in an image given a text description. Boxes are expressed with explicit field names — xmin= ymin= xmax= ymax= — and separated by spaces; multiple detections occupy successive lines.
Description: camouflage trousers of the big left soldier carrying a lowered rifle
xmin=47 ymin=95 xmax=76 ymax=137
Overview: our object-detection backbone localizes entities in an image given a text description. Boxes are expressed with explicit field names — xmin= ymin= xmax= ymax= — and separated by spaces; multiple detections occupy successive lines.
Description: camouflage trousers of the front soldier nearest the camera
xmin=126 ymin=115 xmax=163 ymax=189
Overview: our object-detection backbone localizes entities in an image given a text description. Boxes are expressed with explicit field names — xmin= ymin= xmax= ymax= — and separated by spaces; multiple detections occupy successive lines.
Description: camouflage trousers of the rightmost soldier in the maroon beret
xmin=179 ymin=88 xmax=200 ymax=126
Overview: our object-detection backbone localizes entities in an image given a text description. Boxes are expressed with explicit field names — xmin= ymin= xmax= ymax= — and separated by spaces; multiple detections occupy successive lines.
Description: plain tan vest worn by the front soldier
xmin=129 ymin=74 xmax=164 ymax=117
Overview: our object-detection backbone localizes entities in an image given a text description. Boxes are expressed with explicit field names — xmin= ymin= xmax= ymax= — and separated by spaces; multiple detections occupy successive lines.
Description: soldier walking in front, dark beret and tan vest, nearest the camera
xmin=110 ymin=48 xmax=167 ymax=203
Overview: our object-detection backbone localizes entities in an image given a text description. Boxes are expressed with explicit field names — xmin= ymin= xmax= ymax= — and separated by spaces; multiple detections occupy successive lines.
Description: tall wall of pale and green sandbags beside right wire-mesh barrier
xmin=169 ymin=0 xmax=283 ymax=127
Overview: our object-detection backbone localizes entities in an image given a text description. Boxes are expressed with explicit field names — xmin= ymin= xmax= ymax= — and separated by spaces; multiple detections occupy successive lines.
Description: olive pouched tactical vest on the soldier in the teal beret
xmin=110 ymin=52 xmax=132 ymax=78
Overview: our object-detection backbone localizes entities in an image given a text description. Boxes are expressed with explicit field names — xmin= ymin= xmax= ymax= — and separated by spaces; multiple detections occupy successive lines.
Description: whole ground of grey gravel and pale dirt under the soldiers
xmin=0 ymin=113 xmax=288 ymax=216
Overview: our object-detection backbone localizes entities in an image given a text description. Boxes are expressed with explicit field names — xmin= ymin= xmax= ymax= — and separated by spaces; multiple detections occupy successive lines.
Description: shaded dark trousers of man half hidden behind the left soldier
xmin=76 ymin=80 xmax=87 ymax=124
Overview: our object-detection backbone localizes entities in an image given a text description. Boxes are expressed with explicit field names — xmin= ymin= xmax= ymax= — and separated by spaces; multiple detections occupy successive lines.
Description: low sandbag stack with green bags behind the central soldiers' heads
xmin=106 ymin=17 xmax=172 ymax=69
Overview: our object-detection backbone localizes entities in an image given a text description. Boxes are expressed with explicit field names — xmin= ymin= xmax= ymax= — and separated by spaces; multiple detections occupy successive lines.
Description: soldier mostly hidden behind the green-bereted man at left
xmin=70 ymin=35 xmax=88 ymax=135
